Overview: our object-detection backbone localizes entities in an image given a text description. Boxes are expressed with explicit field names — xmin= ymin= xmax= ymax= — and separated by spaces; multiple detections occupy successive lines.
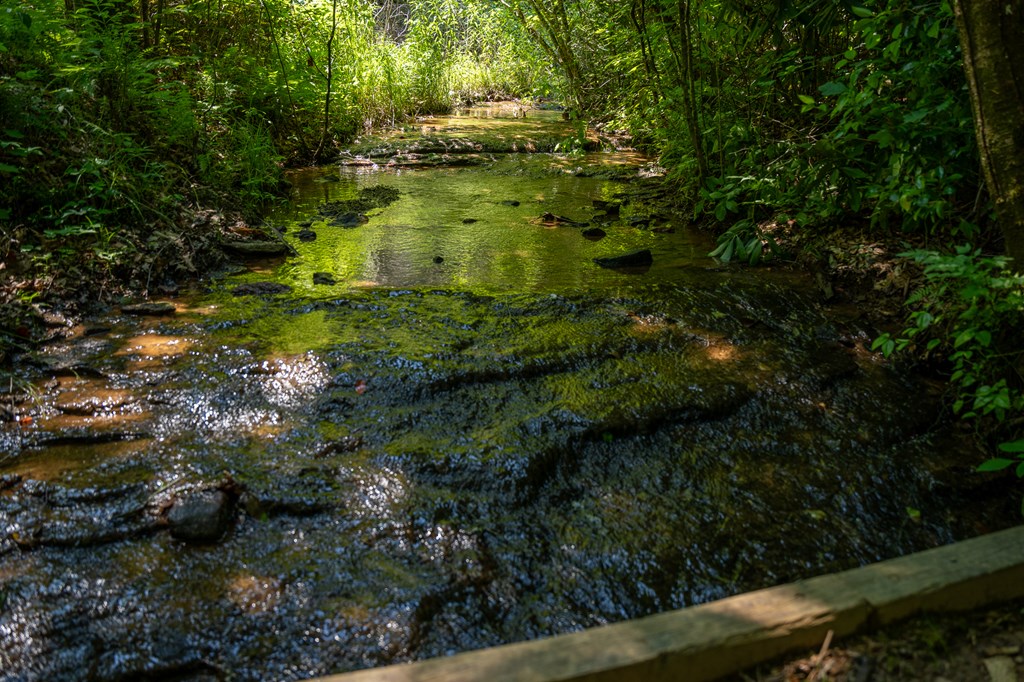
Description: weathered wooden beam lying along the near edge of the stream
xmin=307 ymin=526 xmax=1024 ymax=682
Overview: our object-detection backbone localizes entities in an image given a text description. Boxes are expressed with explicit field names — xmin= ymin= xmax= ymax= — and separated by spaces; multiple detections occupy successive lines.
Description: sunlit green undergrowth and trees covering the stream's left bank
xmin=0 ymin=0 xmax=543 ymax=296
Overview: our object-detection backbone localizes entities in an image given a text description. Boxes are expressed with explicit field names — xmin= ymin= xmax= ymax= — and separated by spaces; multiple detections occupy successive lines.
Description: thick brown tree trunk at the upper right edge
xmin=954 ymin=0 xmax=1024 ymax=271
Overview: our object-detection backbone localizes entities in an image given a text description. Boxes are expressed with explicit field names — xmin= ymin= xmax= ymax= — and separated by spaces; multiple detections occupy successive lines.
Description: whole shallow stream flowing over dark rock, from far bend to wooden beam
xmin=0 ymin=103 xmax=1000 ymax=680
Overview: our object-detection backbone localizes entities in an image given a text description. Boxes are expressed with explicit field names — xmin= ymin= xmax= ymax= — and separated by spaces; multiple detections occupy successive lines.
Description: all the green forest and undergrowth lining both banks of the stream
xmin=0 ymin=0 xmax=1024 ymax=462
